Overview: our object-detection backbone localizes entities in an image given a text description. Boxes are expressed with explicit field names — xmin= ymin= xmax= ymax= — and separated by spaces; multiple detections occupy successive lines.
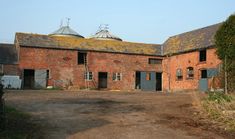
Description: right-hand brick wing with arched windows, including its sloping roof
xmin=163 ymin=24 xmax=221 ymax=91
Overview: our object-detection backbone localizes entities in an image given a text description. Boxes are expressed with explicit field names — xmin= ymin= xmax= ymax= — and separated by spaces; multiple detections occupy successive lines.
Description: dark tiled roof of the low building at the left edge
xmin=0 ymin=43 xmax=18 ymax=64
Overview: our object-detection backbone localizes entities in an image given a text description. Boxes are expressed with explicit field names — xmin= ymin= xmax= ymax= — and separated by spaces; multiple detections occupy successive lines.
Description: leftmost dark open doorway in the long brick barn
xmin=24 ymin=69 xmax=34 ymax=89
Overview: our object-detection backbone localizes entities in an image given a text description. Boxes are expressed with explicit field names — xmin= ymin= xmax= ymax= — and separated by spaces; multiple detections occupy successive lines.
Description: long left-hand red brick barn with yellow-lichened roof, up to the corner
xmin=15 ymin=26 xmax=163 ymax=90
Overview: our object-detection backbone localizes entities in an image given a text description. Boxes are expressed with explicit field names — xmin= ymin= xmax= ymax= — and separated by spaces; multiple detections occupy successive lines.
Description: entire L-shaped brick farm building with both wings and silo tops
xmin=0 ymin=24 xmax=221 ymax=91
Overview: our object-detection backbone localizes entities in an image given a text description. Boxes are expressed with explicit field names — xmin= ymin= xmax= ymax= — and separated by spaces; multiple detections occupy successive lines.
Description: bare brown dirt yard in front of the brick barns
xmin=5 ymin=90 xmax=235 ymax=139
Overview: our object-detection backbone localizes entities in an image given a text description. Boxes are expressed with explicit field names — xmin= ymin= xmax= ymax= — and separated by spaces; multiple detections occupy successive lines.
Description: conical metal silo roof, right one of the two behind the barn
xmin=91 ymin=28 xmax=122 ymax=41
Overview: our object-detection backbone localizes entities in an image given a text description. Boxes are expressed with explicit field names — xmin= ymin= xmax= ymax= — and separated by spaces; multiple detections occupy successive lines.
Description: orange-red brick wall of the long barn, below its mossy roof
xmin=19 ymin=47 xmax=162 ymax=90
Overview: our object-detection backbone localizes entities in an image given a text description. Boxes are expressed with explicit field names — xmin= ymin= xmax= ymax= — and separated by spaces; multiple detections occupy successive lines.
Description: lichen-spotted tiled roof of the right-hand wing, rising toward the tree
xmin=163 ymin=23 xmax=221 ymax=55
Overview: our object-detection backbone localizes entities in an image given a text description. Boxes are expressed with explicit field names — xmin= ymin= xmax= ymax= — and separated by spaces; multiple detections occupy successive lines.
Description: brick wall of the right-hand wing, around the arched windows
xmin=163 ymin=49 xmax=221 ymax=91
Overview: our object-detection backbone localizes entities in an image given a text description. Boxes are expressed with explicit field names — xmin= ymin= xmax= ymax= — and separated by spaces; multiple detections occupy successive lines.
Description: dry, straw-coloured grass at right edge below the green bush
xmin=202 ymin=92 xmax=235 ymax=131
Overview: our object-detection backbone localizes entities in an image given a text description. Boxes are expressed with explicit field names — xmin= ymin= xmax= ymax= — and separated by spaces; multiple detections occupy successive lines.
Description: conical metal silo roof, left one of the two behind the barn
xmin=49 ymin=26 xmax=84 ymax=38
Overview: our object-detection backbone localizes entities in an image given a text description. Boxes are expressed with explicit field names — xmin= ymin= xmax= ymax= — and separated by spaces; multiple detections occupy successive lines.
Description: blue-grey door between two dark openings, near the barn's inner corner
xmin=140 ymin=72 xmax=156 ymax=91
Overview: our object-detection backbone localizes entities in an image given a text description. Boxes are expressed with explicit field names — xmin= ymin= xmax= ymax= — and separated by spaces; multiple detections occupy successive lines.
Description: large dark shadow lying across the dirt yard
xmin=24 ymin=98 xmax=145 ymax=138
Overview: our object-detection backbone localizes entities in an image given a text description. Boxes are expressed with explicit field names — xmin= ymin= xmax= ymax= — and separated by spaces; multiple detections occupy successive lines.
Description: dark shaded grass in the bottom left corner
xmin=0 ymin=106 xmax=40 ymax=139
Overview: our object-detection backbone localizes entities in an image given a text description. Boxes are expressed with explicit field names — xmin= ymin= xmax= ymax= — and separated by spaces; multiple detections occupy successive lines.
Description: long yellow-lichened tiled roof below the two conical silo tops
xmin=16 ymin=33 xmax=161 ymax=55
